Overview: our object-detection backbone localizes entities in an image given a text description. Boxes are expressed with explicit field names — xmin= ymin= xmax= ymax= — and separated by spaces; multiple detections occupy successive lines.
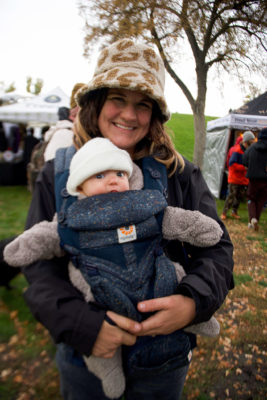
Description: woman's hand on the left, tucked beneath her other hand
xmin=92 ymin=311 xmax=141 ymax=358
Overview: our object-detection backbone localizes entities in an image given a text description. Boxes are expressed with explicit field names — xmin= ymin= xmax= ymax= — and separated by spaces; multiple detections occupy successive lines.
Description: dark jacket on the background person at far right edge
xmin=243 ymin=137 xmax=267 ymax=181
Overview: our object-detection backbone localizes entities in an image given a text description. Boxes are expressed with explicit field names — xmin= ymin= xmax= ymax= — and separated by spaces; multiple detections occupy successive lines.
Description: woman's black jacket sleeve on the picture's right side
xmin=168 ymin=159 xmax=234 ymax=323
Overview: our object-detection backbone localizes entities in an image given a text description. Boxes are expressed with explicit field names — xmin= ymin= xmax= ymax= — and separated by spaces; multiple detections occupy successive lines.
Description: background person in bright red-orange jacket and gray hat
xmin=221 ymin=131 xmax=255 ymax=220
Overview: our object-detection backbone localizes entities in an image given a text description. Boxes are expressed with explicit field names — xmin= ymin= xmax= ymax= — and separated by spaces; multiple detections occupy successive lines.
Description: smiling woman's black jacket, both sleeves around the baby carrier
xmin=24 ymin=156 xmax=234 ymax=355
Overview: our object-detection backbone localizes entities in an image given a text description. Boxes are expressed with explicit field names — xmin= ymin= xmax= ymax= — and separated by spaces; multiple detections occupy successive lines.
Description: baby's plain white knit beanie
xmin=67 ymin=138 xmax=133 ymax=196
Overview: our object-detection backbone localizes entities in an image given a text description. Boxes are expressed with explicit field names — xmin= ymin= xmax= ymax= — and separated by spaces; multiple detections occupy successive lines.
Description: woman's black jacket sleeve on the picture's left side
xmin=23 ymin=161 xmax=105 ymax=355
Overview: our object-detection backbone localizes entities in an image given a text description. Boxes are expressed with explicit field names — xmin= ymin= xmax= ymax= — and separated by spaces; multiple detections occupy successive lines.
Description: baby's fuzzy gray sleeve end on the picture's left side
xmin=4 ymin=220 xmax=65 ymax=267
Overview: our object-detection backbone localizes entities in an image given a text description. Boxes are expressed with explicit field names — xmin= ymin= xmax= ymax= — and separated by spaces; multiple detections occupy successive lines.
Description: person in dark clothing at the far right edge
xmin=243 ymin=128 xmax=267 ymax=231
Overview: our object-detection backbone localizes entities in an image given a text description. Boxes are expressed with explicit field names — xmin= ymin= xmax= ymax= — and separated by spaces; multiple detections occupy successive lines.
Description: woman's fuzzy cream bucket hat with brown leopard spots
xmin=76 ymin=39 xmax=170 ymax=121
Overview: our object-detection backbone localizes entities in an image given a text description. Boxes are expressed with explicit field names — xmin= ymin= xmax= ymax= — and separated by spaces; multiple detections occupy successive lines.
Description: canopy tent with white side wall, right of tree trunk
xmin=203 ymin=92 xmax=267 ymax=198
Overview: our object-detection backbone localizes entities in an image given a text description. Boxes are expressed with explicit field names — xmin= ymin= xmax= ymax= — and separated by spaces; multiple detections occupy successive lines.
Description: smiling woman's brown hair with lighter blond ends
xmin=74 ymin=88 xmax=184 ymax=175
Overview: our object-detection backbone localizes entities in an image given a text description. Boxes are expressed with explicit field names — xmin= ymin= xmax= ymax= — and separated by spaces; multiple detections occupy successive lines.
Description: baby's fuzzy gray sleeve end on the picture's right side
xmin=162 ymin=206 xmax=223 ymax=247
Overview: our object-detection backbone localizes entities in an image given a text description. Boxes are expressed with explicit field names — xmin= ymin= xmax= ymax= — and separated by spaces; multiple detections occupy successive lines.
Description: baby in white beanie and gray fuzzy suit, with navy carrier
xmin=4 ymin=138 xmax=222 ymax=398
